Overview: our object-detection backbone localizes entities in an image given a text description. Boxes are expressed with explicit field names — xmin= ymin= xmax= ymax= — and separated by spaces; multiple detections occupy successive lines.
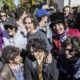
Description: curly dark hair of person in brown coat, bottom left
xmin=2 ymin=46 xmax=20 ymax=63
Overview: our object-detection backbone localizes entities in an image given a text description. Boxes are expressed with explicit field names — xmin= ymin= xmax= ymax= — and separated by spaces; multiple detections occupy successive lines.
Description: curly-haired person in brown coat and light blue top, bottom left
xmin=0 ymin=46 xmax=25 ymax=80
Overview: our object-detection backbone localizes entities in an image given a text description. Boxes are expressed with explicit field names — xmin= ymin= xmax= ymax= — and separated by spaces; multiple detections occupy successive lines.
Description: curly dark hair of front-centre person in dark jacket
xmin=26 ymin=38 xmax=47 ymax=55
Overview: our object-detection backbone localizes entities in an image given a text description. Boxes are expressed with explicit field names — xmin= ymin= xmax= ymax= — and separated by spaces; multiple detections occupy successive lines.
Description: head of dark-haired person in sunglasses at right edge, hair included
xmin=63 ymin=36 xmax=80 ymax=60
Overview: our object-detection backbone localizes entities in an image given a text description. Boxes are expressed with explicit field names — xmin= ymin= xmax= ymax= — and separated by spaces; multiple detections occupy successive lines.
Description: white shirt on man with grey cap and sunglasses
xmin=3 ymin=30 xmax=27 ymax=50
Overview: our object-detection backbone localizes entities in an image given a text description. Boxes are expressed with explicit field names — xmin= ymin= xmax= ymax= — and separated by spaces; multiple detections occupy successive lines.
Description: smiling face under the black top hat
xmin=53 ymin=23 xmax=65 ymax=34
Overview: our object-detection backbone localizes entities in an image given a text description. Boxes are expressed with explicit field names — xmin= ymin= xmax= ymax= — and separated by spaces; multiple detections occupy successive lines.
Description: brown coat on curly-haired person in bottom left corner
xmin=0 ymin=64 xmax=16 ymax=80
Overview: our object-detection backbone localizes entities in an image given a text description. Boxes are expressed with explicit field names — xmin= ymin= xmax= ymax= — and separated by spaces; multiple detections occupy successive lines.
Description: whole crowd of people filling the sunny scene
xmin=0 ymin=3 xmax=80 ymax=80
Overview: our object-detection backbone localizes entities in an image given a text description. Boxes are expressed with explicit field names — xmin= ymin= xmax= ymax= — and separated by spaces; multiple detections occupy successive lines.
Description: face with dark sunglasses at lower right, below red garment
xmin=65 ymin=45 xmax=76 ymax=59
